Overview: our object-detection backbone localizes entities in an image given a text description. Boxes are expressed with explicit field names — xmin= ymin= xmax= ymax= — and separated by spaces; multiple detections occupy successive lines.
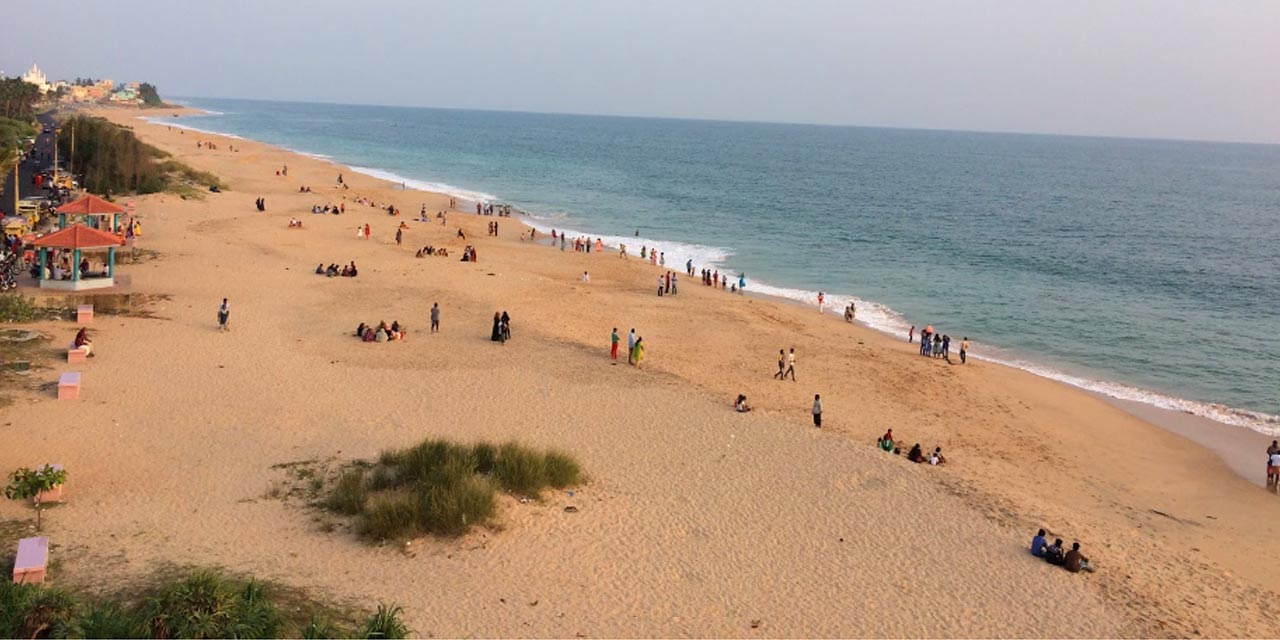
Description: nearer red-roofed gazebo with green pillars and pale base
xmin=31 ymin=224 xmax=124 ymax=291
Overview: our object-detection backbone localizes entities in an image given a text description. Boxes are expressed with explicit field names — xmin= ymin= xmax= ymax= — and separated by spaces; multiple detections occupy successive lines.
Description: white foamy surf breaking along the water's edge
xmin=147 ymin=105 xmax=1280 ymax=450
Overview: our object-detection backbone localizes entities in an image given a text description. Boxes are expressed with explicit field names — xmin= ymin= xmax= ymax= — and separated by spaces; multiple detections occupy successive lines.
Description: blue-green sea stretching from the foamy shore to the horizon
xmin=151 ymin=97 xmax=1280 ymax=435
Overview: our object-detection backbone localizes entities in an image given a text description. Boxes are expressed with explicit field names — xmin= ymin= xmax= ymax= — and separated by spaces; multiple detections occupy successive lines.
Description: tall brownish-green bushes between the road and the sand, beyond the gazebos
xmin=58 ymin=115 xmax=227 ymax=197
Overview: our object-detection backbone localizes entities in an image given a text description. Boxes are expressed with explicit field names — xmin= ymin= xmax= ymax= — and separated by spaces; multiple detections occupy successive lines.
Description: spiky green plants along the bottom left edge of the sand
xmin=0 ymin=570 xmax=411 ymax=639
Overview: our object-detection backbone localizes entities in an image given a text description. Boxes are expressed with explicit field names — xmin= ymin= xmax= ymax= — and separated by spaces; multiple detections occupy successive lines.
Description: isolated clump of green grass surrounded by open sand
xmin=324 ymin=439 xmax=584 ymax=540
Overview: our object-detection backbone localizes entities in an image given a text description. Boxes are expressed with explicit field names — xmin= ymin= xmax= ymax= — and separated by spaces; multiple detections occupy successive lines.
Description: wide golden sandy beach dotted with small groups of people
xmin=0 ymin=110 xmax=1280 ymax=637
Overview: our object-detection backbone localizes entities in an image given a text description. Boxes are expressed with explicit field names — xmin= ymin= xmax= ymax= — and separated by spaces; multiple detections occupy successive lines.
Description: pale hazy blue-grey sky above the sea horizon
xmin=0 ymin=0 xmax=1280 ymax=143
